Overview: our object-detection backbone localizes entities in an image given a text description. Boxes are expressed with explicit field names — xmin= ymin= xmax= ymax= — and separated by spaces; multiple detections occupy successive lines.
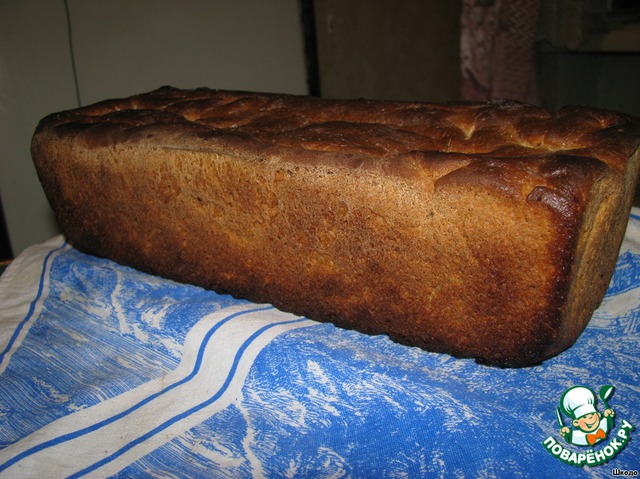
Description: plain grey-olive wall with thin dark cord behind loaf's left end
xmin=0 ymin=0 xmax=307 ymax=255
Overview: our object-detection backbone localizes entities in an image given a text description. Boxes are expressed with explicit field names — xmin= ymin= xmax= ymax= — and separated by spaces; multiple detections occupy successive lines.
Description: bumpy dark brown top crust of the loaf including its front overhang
xmin=39 ymin=87 xmax=640 ymax=217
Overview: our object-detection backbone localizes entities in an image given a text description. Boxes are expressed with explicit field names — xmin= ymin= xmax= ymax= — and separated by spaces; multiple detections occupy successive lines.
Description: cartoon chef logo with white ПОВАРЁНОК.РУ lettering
xmin=542 ymin=385 xmax=634 ymax=466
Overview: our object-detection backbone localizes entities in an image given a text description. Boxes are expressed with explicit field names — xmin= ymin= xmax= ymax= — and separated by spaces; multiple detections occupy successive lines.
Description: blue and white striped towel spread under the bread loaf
xmin=0 ymin=209 xmax=640 ymax=478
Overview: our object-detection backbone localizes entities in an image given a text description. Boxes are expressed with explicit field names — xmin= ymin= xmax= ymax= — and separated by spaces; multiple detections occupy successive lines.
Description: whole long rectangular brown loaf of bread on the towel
xmin=32 ymin=87 xmax=640 ymax=367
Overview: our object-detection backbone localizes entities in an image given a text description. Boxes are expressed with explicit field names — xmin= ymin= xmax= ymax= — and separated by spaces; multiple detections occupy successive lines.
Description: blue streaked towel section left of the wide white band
xmin=0 ymin=244 xmax=238 ymax=450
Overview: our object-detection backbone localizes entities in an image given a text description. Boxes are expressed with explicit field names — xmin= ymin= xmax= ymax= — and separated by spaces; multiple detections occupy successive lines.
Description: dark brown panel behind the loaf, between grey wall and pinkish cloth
xmin=314 ymin=0 xmax=461 ymax=101
